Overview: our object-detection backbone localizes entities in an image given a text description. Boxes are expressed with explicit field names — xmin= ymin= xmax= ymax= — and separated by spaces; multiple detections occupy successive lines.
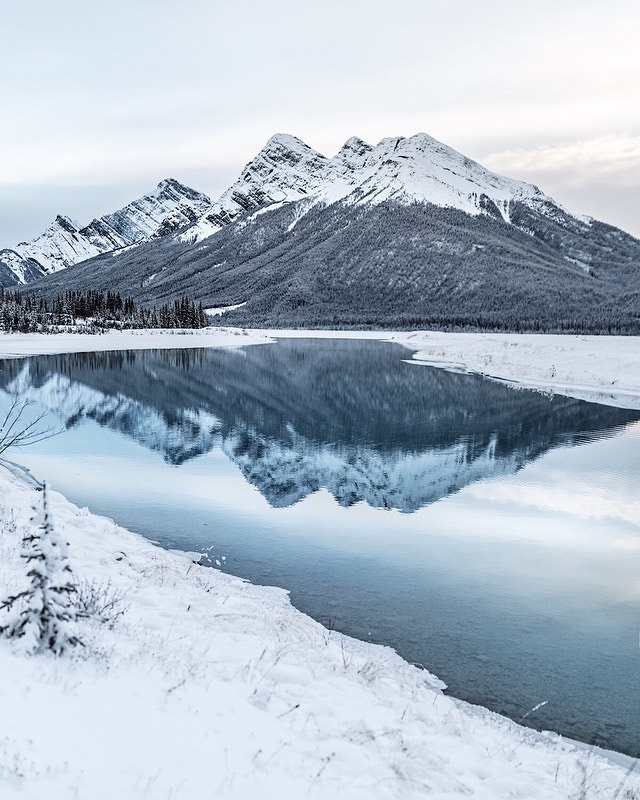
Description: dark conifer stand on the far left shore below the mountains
xmin=0 ymin=288 xmax=208 ymax=333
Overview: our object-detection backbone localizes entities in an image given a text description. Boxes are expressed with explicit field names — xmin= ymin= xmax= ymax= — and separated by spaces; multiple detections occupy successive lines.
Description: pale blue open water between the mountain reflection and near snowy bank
xmin=3 ymin=388 xmax=640 ymax=749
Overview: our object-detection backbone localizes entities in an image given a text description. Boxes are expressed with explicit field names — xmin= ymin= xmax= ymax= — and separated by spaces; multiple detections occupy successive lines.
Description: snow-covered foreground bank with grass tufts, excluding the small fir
xmin=0 ymin=465 xmax=640 ymax=800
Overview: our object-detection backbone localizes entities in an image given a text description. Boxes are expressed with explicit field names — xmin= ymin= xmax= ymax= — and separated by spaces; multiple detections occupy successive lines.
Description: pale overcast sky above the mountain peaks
xmin=0 ymin=0 xmax=640 ymax=246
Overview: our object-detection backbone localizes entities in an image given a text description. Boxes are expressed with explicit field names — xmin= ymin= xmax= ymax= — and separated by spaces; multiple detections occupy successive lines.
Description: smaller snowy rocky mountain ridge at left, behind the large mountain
xmin=0 ymin=178 xmax=211 ymax=286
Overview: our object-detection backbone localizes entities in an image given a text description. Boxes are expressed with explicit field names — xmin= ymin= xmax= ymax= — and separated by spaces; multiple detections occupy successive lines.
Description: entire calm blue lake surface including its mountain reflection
xmin=0 ymin=340 xmax=640 ymax=755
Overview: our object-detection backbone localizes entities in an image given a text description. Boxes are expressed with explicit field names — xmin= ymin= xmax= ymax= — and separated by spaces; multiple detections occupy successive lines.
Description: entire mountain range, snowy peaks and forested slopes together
xmin=0 ymin=134 xmax=640 ymax=333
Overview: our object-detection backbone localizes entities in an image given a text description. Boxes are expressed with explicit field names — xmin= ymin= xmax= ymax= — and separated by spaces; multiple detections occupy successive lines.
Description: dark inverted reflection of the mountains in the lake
xmin=0 ymin=339 xmax=640 ymax=512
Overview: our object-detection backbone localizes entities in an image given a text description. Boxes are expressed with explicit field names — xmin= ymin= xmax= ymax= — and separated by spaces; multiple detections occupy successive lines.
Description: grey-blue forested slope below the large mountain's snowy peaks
xmin=22 ymin=202 xmax=640 ymax=333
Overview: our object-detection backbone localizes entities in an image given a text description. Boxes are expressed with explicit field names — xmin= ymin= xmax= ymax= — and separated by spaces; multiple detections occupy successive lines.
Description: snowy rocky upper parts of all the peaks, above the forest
xmin=0 ymin=133 xmax=591 ymax=286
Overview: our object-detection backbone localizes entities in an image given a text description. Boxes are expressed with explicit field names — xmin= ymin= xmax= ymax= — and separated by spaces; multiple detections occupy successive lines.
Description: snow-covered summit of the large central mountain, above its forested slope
xmin=180 ymin=133 xmax=564 ymax=242
